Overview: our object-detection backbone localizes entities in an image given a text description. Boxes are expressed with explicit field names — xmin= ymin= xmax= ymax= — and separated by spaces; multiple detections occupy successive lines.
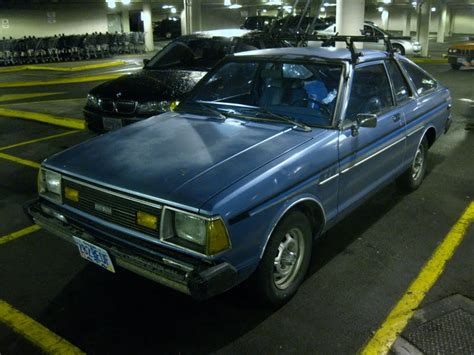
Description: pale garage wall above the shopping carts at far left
xmin=0 ymin=2 xmax=107 ymax=38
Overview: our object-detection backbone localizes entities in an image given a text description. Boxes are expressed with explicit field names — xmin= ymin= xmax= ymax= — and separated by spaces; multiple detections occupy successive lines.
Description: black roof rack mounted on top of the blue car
xmin=278 ymin=34 xmax=395 ymax=63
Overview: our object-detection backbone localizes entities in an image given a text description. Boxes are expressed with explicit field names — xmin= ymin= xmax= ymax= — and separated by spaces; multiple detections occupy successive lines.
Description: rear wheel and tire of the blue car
xmin=397 ymin=136 xmax=428 ymax=192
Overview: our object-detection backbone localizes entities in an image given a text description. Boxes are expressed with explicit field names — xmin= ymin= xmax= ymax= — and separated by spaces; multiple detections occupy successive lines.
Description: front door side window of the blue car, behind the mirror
xmin=346 ymin=64 xmax=393 ymax=121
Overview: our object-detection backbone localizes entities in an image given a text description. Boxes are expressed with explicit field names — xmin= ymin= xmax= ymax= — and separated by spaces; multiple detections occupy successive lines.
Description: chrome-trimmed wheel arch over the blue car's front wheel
xmin=260 ymin=195 xmax=326 ymax=259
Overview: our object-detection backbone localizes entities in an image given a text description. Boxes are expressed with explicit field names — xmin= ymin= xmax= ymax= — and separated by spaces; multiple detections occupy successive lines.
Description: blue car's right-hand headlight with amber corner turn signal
xmin=161 ymin=208 xmax=230 ymax=255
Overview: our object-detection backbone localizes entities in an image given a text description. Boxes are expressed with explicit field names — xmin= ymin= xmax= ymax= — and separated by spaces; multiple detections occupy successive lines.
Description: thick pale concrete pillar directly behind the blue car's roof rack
xmin=336 ymin=0 xmax=365 ymax=48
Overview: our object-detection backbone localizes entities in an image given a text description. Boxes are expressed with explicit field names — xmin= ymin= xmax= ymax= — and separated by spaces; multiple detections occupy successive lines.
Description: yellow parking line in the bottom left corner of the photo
xmin=0 ymin=300 xmax=85 ymax=354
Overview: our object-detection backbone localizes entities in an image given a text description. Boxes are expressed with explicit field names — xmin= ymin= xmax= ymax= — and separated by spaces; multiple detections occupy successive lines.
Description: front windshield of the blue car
xmin=185 ymin=60 xmax=342 ymax=127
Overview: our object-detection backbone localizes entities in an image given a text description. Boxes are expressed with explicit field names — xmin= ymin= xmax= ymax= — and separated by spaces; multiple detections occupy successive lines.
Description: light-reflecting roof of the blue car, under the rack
xmin=234 ymin=47 xmax=388 ymax=63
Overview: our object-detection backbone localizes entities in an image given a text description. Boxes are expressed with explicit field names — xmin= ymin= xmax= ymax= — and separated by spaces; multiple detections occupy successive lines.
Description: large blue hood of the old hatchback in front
xmin=43 ymin=113 xmax=311 ymax=210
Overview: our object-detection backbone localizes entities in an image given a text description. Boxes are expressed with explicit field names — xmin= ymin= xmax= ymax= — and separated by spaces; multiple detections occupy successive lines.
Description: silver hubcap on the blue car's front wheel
xmin=273 ymin=228 xmax=304 ymax=290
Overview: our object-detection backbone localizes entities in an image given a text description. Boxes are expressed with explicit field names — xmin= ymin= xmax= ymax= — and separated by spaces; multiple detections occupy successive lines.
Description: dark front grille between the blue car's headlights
xmin=62 ymin=178 xmax=161 ymax=237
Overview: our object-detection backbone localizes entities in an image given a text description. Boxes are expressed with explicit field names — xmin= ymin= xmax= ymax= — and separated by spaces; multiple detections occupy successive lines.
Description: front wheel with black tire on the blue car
xmin=252 ymin=210 xmax=312 ymax=306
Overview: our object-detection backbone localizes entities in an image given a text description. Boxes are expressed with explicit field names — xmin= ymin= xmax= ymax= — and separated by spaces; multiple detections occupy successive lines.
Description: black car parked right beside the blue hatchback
xmin=84 ymin=30 xmax=286 ymax=132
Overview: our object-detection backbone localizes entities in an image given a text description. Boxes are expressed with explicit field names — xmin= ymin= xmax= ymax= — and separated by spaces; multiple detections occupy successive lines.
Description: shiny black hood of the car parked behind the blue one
xmin=91 ymin=69 xmax=206 ymax=102
